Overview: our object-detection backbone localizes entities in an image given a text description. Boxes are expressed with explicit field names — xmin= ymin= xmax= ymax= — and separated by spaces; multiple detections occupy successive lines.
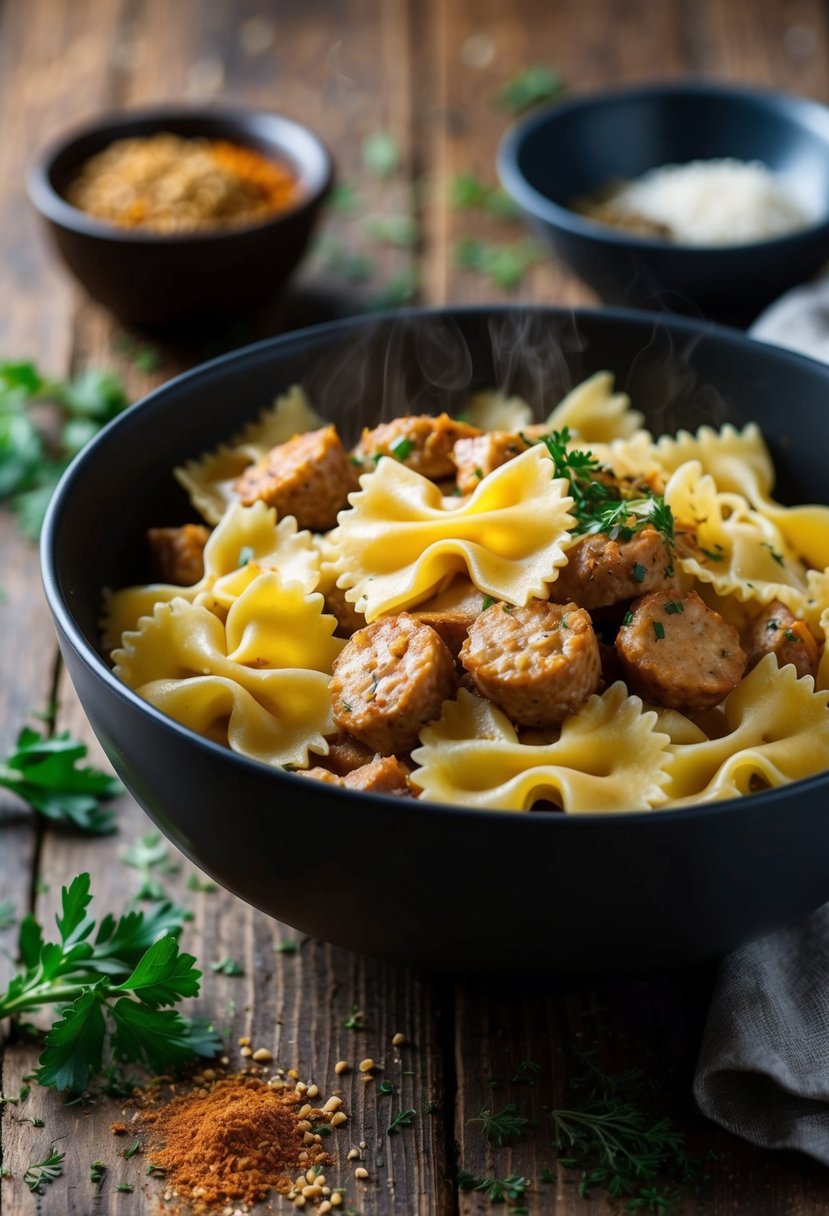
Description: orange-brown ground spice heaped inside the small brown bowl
xmin=67 ymin=131 xmax=298 ymax=232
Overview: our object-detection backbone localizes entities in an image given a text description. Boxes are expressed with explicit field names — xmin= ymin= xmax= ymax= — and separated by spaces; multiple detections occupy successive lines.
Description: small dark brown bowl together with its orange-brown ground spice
xmin=29 ymin=107 xmax=332 ymax=330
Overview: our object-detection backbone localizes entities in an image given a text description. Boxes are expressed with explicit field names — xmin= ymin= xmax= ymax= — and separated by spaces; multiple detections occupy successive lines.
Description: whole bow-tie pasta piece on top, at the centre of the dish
xmin=331 ymin=444 xmax=575 ymax=621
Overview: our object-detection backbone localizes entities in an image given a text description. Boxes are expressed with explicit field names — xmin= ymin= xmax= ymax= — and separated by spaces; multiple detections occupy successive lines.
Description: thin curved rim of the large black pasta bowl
xmin=40 ymin=304 xmax=829 ymax=832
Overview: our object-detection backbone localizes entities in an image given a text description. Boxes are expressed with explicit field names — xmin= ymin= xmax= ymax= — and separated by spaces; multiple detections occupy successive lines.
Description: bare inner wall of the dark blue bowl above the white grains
xmin=511 ymin=85 xmax=829 ymax=241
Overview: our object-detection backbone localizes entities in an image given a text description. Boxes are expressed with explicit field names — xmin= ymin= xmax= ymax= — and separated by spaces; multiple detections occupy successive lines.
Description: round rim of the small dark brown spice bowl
xmin=26 ymin=102 xmax=334 ymax=247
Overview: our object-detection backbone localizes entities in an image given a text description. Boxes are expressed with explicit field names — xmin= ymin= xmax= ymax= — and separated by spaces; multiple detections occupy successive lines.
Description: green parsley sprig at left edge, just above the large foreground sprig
xmin=0 ymin=726 xmax=122 ymax=835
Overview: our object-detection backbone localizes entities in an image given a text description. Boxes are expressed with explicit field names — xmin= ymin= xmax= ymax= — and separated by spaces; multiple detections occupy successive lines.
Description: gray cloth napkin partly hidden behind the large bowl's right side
xmin=694 ymin=276 xmax=829 ymax=1165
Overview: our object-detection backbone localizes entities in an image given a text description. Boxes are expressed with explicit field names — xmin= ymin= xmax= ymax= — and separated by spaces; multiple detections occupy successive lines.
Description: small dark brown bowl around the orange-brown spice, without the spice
xmin=28 ymin=107 xmax=332 ymax=328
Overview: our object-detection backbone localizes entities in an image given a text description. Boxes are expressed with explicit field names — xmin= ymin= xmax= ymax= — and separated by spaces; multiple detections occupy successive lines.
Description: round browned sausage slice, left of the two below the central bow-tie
xmin=328 ymin=613 xmax=456 ymax=755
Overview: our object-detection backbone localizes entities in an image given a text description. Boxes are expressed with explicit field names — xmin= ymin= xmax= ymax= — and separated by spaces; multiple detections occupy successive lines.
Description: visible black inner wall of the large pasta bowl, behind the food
xmin=44 ymin=309 xmax=829 ymax=675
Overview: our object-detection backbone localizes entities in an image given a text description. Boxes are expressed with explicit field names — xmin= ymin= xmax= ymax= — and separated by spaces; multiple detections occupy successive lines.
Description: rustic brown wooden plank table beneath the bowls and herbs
xmin=0 ymin=0 xmax=829 ymax=1216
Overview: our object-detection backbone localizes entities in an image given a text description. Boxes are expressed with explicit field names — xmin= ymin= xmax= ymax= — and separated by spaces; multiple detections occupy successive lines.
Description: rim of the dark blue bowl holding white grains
xmin=496 ymin=79 xmax=829 ymax=258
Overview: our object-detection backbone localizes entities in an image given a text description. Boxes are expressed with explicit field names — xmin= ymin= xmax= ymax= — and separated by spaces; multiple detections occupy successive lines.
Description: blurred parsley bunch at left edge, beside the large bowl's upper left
xmin=0 ymin=362 xmax=129 ymax=539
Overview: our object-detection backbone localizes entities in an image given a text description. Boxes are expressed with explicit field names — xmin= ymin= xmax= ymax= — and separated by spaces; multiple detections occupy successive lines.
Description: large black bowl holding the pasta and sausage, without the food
xmin=43 ymin=308 xmax=829 ymax=972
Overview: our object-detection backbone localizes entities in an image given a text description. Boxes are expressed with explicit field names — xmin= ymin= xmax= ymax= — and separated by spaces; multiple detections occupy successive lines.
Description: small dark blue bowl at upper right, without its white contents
xmin=498 ymin=84 xmax=829 ymax=325
